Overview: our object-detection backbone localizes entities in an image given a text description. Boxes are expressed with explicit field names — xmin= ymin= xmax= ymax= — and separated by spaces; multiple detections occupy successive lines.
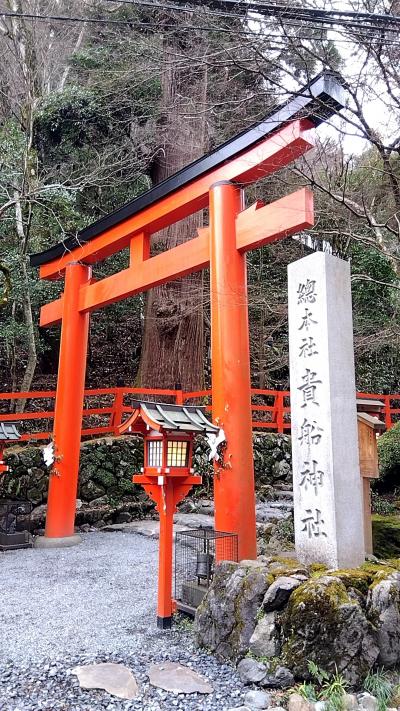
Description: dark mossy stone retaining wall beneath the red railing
xmin=0 ymin=434 xmax=291 ymax=529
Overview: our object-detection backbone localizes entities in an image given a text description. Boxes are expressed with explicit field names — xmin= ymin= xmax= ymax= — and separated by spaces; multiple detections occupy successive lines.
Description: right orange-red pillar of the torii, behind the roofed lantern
xmin=210 ymin=181 xmax=257 ymax=560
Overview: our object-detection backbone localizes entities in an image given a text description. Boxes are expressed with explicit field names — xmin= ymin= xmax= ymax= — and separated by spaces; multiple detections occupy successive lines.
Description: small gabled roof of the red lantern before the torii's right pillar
xmin=119 ymin=400 xmax=220 ymax=434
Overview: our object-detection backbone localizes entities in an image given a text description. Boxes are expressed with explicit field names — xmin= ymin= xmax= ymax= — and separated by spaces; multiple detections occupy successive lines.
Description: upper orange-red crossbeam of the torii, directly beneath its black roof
xmin=40 ymin=119 xmax=314 ymax=282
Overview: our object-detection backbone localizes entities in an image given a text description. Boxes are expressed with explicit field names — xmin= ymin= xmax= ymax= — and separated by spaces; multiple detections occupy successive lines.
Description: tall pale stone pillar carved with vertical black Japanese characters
xmin=288 ymin=252 xmax=365 ymax=568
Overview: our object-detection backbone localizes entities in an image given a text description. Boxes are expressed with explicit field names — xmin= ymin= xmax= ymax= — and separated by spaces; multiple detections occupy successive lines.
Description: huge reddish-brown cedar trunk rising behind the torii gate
xmin=139 ymin=36 xmax=207 ymax=390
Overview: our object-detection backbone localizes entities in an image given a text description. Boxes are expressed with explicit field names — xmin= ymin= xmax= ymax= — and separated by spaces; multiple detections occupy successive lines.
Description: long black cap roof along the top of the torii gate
xmin=30 ymin=72 xmax=345 ymax=267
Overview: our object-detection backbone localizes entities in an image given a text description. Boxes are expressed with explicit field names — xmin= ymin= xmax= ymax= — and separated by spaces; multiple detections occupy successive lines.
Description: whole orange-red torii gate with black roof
xmin=31 ymin=75 xmax=343 ymax=559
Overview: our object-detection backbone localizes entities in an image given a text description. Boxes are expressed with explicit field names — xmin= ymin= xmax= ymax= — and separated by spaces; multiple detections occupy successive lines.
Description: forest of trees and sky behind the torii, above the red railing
xmin=0 ymin=0 xmax=400 ymax=407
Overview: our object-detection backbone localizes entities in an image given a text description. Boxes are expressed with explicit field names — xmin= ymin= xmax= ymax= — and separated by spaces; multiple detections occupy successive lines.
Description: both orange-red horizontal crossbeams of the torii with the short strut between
xmin=40 ymin=119 xmax=313 ymax=326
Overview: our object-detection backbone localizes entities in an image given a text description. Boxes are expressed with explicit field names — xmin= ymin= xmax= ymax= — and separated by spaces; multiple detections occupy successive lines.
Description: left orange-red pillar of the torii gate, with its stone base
xmin=38 ymin=262 xmax=91 ymax=546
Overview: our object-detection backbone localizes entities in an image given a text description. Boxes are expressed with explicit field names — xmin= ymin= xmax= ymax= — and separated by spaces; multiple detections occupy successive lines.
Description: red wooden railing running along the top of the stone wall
xmin=0 ymin=387 xmax=400 ymax=440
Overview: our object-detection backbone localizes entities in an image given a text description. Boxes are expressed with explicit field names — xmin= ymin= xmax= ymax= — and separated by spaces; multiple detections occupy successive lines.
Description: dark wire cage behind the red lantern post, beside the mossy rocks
xmin=175 ymin=528 xmax=238 ymax=615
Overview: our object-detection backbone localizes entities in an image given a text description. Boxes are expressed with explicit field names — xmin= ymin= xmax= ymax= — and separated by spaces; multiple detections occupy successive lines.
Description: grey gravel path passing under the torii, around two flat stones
xmin=0 ymin=533 xmax=243 ymax=711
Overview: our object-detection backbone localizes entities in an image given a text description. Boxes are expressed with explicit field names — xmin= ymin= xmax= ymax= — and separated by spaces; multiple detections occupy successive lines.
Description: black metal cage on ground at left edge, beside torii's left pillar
xmin=0 ymin=499 xmax=33 ymax=551
